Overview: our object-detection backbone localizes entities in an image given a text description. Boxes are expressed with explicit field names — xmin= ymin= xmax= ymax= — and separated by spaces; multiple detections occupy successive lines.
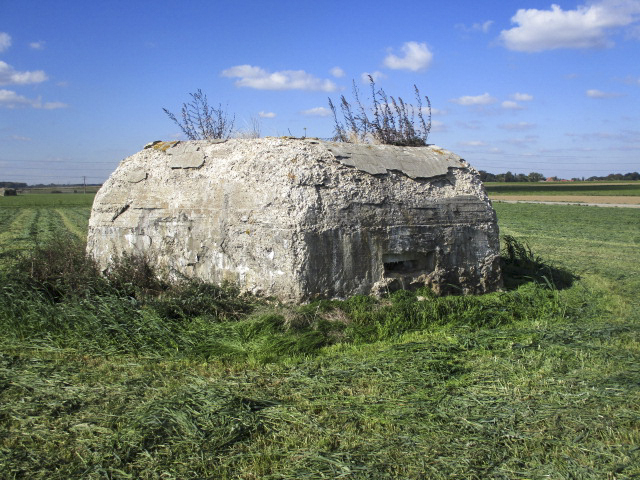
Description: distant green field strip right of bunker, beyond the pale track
xmin=485 ymin=182 xmax=640 ymax=196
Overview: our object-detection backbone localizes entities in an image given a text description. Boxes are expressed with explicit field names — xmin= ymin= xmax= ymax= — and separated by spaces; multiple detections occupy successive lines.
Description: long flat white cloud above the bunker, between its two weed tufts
xmin=222 ymin=65 xmax=338 ymax=92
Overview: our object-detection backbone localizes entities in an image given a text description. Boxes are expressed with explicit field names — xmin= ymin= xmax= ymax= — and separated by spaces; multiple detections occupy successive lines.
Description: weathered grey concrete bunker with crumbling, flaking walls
xmin=88 ymin=138 xmax=501 ymax=301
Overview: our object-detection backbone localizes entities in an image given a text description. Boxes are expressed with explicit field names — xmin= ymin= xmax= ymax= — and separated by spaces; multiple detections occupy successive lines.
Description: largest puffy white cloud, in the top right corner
xmin=500 ymin=0 xmax=640 ymax=52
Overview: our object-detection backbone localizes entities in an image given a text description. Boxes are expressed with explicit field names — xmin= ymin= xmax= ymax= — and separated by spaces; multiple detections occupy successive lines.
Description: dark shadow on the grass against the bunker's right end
xmin=502 ymin=235 xmax=579 ymax=290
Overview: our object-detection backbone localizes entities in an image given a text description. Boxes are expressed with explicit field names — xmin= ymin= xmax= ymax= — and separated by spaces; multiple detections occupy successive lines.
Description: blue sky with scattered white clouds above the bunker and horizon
xmin=0 ymin=0 xmax=640 ymax=184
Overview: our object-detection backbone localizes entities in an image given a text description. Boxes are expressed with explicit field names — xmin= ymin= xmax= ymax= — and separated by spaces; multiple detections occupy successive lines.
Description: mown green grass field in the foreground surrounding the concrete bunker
xmin=0 ymin=193 xmax=640 ymax=480
